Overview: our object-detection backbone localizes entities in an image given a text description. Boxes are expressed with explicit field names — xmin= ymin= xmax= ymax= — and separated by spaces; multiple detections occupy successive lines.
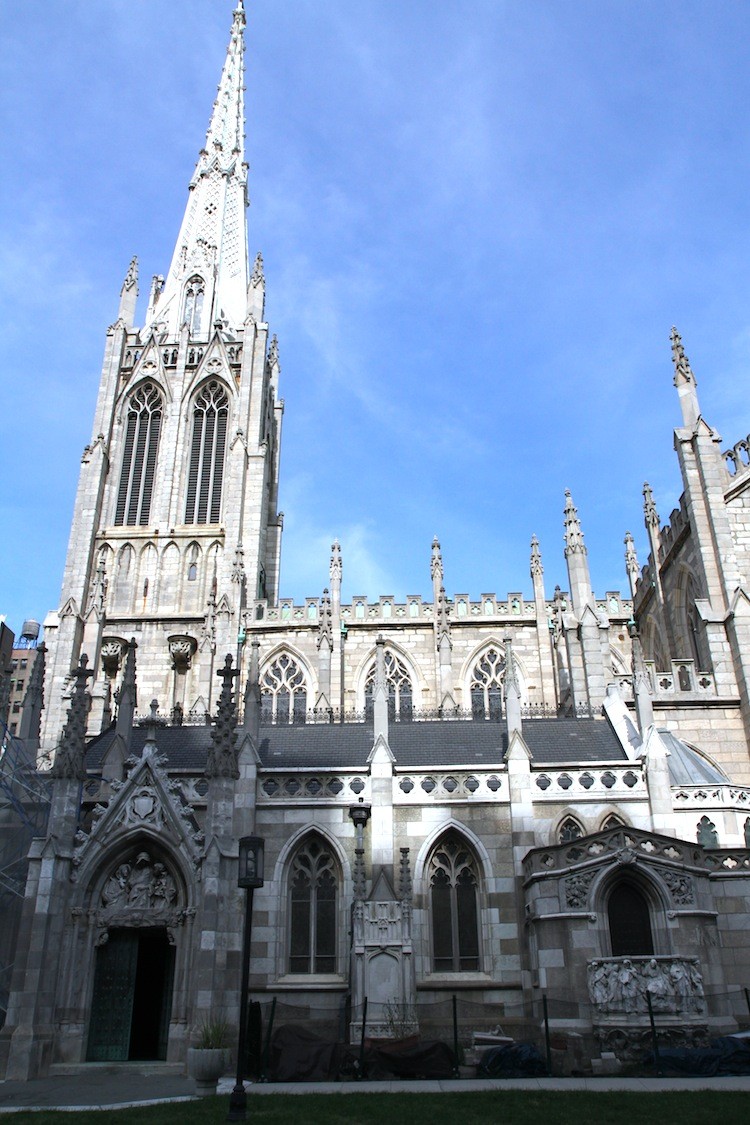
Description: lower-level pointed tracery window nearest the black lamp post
xmin=289 ymin=837 xmax=338 ymax=973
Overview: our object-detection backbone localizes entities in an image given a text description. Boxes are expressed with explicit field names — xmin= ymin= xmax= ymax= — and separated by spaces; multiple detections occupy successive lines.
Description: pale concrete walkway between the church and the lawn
xmin=0 ymin=1063 xmax=750 ymax=1114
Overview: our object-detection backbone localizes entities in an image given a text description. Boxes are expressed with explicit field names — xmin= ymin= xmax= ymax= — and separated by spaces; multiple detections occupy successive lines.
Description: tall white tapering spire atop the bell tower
xmin=146 ymin=0 xmax=250 ymax=339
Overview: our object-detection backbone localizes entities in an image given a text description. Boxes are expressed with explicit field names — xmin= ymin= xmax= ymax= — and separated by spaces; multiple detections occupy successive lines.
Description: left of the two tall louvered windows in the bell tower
xmin=115 ymin=383 xmax=163 ymax=527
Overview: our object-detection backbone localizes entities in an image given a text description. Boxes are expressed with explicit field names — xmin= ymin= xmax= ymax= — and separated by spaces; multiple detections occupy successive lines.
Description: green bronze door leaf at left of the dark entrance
xmin=87 ymin=929 xmax=138 ymax=1062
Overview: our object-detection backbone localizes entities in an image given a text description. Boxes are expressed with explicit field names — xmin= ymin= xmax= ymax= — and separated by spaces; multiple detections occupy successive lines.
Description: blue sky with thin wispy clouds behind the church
xmin=0 ymin=0 xmax=750 ymax=631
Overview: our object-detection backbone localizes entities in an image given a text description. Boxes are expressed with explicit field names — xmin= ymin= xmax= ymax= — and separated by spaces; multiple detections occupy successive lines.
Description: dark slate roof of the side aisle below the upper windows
xmin=87 ymin=719 xmax=627 ymax=772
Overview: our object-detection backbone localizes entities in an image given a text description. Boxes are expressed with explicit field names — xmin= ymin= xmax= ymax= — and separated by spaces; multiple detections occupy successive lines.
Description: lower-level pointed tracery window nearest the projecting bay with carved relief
xmin=427 ymin=833 xmax=479 ymax=973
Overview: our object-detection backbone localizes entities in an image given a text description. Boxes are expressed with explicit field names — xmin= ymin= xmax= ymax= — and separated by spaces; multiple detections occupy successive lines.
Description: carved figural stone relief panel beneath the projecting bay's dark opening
xmin=588 ymin=956 xmax=706 ymax=1023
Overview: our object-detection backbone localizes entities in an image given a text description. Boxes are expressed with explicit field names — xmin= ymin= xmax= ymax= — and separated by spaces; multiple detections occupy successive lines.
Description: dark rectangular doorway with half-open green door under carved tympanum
xmin=87 ymin=926 xmax=174 ymax=1062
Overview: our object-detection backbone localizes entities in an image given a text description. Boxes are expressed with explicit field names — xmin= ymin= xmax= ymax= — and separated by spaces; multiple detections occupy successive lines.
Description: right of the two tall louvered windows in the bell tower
xmin=184 ymin=379 xmax=229 ymax=523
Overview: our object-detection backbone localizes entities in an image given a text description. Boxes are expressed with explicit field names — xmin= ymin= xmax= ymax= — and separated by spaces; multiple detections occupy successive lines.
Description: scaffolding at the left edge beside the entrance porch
xmin=0 ymin=722 xmax=52 ymax=1026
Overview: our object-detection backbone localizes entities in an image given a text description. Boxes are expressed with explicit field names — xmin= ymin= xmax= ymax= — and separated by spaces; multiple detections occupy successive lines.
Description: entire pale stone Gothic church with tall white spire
xmin=0 ymin=0 xmax=750 ymax=1079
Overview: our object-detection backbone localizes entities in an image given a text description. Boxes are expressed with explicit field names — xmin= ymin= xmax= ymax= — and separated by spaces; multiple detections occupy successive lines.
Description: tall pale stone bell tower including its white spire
xmin=42 ymin=0 xmax=283 ymax=754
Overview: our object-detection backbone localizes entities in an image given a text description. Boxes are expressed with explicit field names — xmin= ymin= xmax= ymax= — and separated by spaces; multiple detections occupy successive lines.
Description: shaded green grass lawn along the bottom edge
xmin=8 ymin=1090 xmax=750 ymax=1125
